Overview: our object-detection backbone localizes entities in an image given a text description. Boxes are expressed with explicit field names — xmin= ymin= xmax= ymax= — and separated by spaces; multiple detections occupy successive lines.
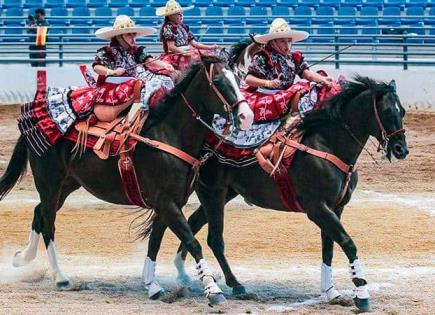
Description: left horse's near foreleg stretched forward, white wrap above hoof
xmin=156 ymin=203 xmax=226 ymax=304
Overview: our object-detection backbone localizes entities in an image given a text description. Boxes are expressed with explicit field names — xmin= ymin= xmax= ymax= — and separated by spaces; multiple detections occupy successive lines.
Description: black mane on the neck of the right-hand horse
xmin=298 ymin=75 xmax=394 ymax=133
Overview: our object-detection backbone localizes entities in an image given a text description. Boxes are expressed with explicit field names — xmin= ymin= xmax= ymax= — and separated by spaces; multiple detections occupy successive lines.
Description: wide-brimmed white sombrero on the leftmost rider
xmin=95 ymin=15 xmax=156 ymax=39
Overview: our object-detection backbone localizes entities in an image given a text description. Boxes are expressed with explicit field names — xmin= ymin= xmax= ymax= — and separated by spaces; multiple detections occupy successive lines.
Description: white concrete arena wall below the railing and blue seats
xmin=0 ymin=65 xmax=435 ymax=111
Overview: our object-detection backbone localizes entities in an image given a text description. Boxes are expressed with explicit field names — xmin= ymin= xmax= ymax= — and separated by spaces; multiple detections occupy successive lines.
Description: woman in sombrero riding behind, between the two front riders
xmin=156 ymin=0 xmax=219 ymax=70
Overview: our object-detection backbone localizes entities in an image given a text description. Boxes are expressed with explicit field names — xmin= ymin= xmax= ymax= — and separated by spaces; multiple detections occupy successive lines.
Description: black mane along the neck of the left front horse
xmin=142 ymin=56 xmax=222 ymax=130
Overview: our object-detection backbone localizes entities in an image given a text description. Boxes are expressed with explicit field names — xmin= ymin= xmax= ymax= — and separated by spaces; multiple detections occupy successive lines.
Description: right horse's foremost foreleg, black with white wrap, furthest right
xmin=305 ymin=205 xmax=371 ymax=312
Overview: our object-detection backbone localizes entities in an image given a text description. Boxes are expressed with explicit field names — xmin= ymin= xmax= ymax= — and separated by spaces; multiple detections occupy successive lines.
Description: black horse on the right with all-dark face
xmin=148 ymin=77 xmax=409 ymax=311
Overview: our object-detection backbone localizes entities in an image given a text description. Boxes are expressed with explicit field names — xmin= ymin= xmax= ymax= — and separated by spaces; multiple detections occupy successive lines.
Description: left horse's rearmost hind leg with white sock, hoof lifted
xmin=12 ymin=182 xmax=80 ymax=267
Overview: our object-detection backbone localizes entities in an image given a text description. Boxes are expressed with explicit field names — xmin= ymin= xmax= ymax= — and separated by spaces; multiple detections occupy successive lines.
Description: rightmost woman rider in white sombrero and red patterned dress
xmin=244 ymin=18 xmax=337 ymax=121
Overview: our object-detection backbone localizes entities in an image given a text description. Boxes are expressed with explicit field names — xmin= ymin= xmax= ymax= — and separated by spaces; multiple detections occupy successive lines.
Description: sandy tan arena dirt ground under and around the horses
xmin=0 ymin=107 xmax=435 ymax=314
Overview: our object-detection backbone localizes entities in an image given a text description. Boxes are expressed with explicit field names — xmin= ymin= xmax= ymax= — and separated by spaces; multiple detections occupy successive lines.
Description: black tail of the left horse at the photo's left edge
xmin=0 ymin=135 xmax=29 ymax=200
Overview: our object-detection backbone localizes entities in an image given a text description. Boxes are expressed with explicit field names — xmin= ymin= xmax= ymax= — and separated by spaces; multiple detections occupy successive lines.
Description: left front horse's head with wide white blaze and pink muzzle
xmin=189 ymin=57 xmax=254 ymax=130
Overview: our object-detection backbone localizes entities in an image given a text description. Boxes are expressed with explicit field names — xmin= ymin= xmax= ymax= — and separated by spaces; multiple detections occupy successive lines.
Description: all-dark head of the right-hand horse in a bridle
xmin=372 ymin=80 xmax=409 ymax=161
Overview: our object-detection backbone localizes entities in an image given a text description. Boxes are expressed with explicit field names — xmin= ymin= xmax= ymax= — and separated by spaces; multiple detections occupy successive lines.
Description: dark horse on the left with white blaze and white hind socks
xmin=0 ymin=58 xmax=253 ymax=304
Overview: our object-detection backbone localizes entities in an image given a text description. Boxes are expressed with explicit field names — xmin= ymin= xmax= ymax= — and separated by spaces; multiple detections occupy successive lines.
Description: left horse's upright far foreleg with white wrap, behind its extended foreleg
xmin=142 ymin=216 xmax=166 ymax=300
